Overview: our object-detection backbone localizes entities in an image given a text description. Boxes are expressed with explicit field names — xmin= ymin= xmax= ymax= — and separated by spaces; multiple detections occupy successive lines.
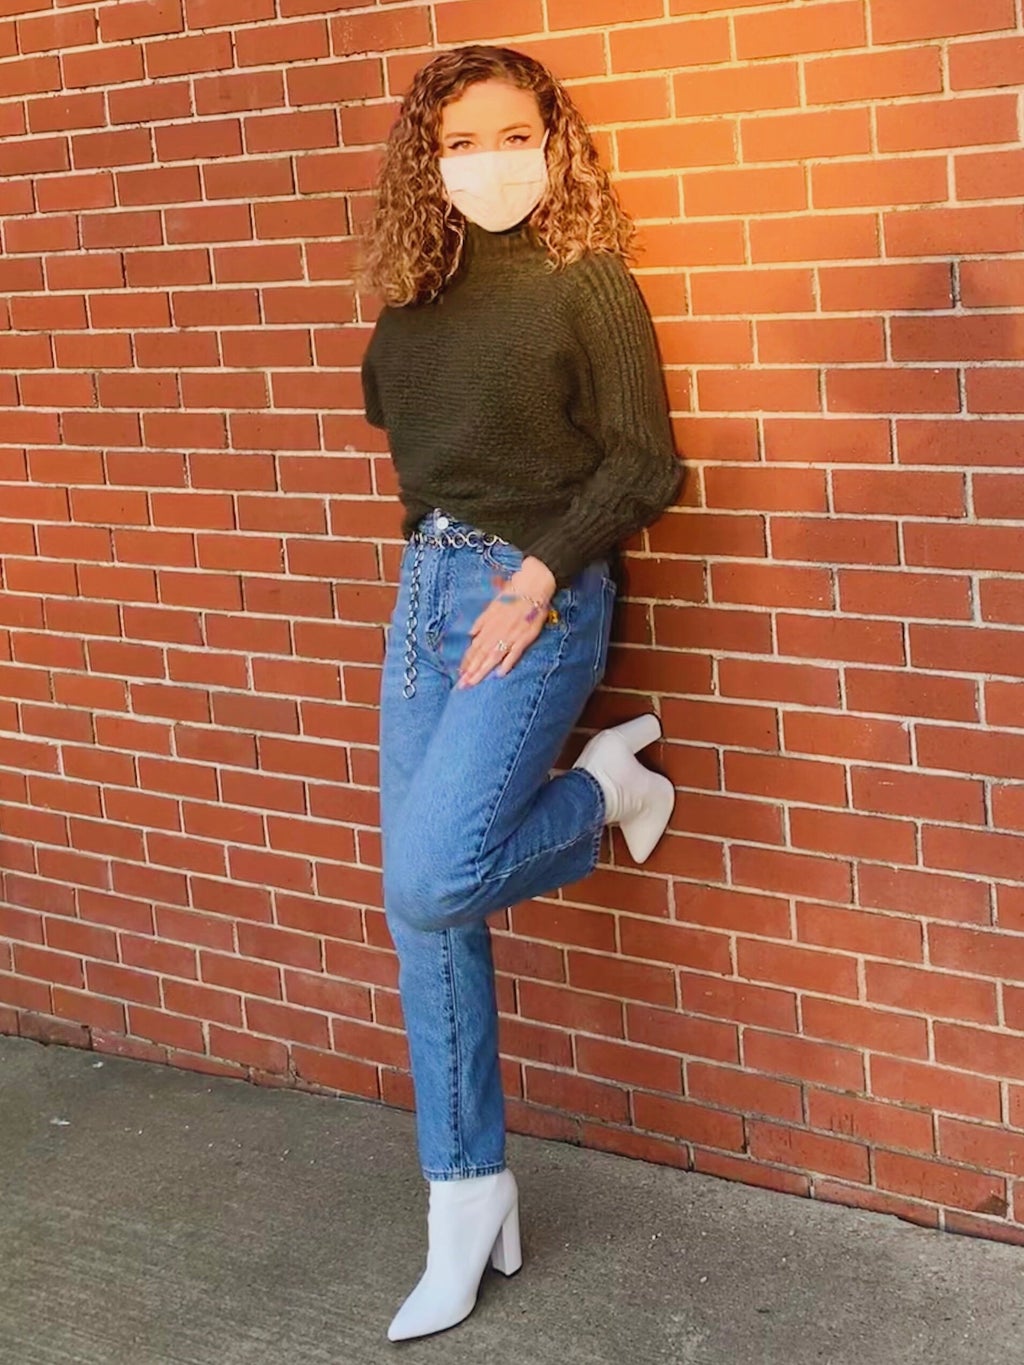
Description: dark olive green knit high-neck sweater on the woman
xmin=362 ymin=224 xmax=681 ymax=584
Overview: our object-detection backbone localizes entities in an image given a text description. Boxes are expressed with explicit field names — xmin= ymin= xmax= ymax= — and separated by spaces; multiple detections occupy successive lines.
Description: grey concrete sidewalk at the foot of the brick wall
xmin=0 ymin=1037 xmax=1024 ymax=1365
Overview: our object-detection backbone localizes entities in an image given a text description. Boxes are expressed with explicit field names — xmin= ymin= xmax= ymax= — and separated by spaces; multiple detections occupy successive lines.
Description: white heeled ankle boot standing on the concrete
xmin=388 ymin=1167 xmax=523 ymax=1342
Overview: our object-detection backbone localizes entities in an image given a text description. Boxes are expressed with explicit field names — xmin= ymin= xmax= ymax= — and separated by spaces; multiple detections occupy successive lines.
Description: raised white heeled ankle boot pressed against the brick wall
xmin=573 ymin=715 xmax=676 ymax=863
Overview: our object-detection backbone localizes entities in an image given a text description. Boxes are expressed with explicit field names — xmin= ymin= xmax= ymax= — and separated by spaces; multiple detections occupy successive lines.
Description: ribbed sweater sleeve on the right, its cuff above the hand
xmin=522 ymin=253 xmax=683 ymax=584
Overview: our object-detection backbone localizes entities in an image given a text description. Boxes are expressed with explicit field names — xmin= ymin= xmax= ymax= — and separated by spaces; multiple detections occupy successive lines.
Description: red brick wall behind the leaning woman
xmin=0 ymin=0 xmax=1024 ymax=1239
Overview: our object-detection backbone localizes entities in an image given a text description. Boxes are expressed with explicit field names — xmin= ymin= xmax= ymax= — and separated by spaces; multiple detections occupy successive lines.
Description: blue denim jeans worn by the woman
xmin=381 ymin=513 xmax=614 ymax=1181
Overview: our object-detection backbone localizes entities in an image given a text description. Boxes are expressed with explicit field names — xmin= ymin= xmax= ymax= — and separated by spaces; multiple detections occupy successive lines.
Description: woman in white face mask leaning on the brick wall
xmin=363 ymin=46 xmax=680 ymax=1340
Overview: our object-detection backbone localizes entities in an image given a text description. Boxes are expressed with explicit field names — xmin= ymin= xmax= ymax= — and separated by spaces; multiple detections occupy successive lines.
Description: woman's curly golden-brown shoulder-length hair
xmin=360 ymin=44 xmax=636 ymax=307
